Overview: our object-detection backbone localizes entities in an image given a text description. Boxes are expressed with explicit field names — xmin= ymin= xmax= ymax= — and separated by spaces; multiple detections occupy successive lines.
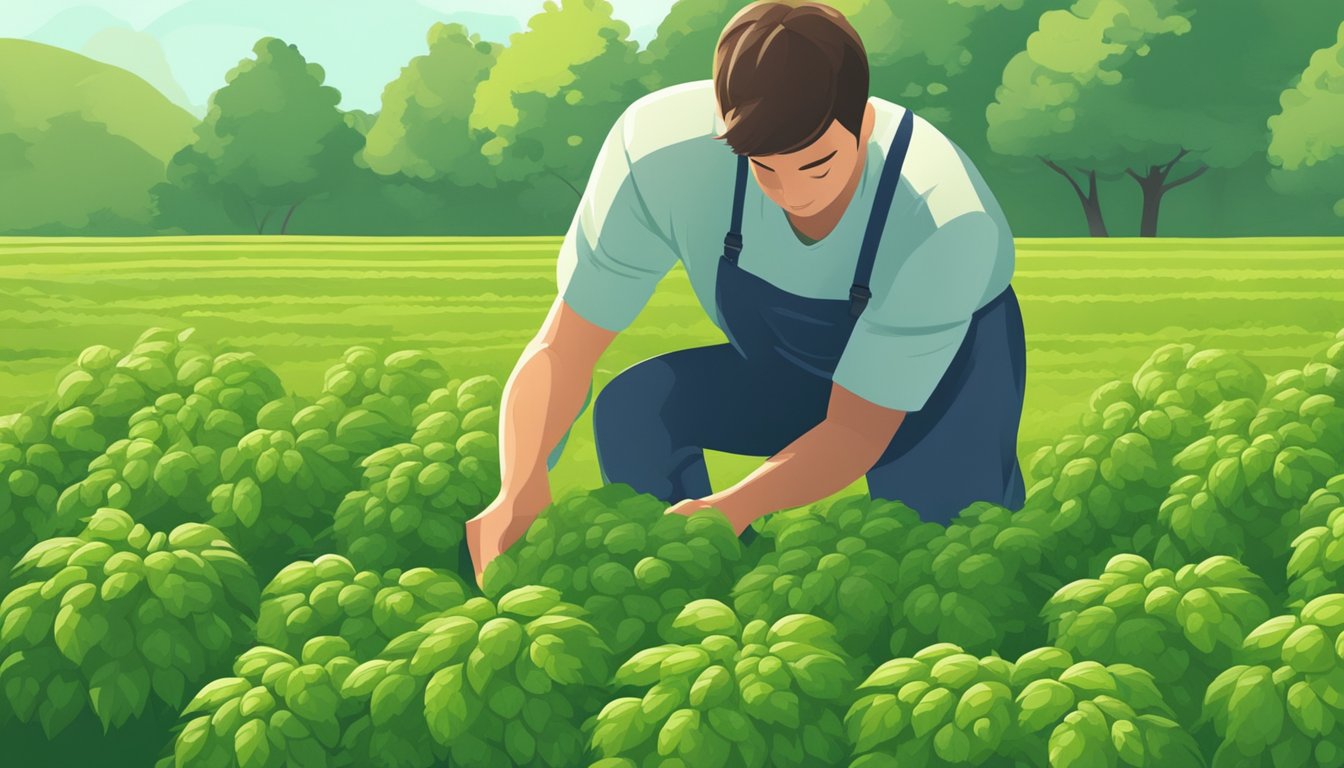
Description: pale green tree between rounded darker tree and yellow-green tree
xmin=363 ymin=23 xmax=501 ymax=186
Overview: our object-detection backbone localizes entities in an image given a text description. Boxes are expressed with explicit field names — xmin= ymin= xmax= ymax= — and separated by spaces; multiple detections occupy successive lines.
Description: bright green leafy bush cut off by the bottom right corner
xmin=1204 ymin=593 xmax=1344 ymax=768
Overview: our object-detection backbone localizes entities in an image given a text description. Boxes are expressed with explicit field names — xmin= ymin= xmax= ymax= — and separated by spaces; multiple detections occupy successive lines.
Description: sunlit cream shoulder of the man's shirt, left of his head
xmin=618 ymin=79 xmax=718 ymax=164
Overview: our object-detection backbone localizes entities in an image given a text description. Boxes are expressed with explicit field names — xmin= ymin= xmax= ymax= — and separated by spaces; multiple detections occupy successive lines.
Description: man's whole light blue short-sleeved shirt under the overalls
xmin=556 ymin=79 xmax=1013 ymax=412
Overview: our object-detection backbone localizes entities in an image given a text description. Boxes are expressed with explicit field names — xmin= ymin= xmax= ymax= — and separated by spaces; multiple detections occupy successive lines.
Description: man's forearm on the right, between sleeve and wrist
xmin=706 ymin=420 xmax=882 ymax=527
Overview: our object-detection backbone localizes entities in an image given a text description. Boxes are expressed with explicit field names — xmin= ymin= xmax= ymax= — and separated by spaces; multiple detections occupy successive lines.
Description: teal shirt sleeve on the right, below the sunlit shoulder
xmin=832 ymin=210 xmax=1003 ymax=412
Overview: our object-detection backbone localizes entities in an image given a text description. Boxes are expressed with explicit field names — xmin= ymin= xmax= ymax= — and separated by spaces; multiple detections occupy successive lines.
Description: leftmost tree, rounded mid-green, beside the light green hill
xmin=157 ymin=38 xmax=363 ymax=234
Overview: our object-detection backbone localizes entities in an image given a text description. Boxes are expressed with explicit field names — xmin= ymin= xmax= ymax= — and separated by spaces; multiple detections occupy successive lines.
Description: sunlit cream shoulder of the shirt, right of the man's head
xmin=872 ymin=97 xmax=1001 ymax=229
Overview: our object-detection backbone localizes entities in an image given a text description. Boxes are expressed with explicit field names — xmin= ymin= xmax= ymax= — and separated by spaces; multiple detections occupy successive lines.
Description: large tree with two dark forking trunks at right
xmin=986 ymin=0 xmax=1337 ymax=237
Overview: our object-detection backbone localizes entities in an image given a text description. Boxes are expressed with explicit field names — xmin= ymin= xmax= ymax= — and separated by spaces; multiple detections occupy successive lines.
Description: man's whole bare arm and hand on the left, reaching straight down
xmin=466 ymin=297 xmax=617 ymax=581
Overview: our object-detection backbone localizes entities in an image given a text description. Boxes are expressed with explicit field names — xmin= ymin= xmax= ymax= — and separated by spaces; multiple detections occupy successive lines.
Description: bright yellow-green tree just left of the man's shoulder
xmin=469 ymin=0 xmax=646 ymax=198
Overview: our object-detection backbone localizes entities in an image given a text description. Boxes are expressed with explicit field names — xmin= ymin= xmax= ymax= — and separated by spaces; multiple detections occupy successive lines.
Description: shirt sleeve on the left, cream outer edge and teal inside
xmin=555 ymin=106 xmax=677 ymax=331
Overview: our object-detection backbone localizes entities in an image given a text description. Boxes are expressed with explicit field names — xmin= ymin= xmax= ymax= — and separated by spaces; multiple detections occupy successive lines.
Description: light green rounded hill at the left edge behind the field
xmin=0 ymin=38 xmax=196 ymax=234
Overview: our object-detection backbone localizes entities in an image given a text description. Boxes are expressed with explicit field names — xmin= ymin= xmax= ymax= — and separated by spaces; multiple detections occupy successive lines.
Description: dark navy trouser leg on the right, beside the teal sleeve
xmin=867 ymin=289 xmax=1027 ymax=525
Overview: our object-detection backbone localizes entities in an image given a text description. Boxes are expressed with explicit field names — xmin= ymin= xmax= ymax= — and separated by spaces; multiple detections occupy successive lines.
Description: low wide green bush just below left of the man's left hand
xmin=257 ymin=554 xmax=466 ymax=660
